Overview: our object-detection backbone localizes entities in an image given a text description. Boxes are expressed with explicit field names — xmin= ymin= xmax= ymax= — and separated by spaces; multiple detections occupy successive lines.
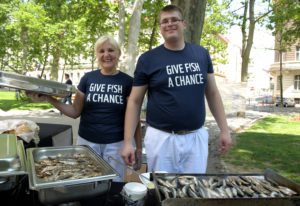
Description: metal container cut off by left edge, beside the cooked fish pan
xmin=0 ymin=134 xmax=27 ymax=176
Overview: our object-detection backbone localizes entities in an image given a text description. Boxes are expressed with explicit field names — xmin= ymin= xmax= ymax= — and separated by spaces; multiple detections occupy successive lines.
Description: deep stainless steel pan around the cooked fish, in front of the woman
xmin=26 ymin=146 xmax=117 ymax=204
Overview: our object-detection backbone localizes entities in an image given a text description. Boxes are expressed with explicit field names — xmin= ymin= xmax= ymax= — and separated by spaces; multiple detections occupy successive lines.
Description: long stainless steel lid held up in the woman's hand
xmin=0 ymin=71 xmax=76 ymax=97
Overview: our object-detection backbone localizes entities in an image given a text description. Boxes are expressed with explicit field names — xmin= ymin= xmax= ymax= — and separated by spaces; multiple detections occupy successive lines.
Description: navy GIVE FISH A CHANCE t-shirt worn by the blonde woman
xmin=78 ymin=70 xmax=132 ymax=144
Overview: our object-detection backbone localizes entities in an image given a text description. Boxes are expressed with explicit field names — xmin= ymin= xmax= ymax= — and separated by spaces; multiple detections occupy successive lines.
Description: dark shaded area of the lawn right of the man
xmin=224 ymin=131 xmax=300 ymax=183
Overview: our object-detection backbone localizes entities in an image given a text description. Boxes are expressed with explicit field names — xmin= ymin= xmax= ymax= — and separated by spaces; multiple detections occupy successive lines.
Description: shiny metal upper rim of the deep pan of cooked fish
xmin=26 ymin=145 xmax=118 ymax=190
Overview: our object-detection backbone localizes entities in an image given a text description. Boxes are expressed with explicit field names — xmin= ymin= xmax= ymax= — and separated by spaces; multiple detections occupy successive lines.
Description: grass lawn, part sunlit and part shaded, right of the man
xmin=223 ymin=115 xmax=300 ymax=184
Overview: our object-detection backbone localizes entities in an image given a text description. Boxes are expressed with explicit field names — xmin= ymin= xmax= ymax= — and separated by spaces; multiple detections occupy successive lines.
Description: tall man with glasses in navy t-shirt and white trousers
xmin=122 ymin=5 xmax=231 ymax=173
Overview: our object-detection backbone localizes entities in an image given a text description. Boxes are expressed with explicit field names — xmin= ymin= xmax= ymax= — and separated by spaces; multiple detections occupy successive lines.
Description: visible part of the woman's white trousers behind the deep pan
xmin=77 ymin=136 xmax=125 ymax=182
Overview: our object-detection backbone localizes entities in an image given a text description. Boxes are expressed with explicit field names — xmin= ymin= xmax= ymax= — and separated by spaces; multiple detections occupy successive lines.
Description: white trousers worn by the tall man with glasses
xmin=144 ymin=126 xmax=208 ymax=173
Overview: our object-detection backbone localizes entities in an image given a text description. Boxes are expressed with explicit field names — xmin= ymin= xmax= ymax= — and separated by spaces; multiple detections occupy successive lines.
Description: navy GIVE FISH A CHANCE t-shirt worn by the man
xmin=133 ymin=43 xmax=213 ymax=131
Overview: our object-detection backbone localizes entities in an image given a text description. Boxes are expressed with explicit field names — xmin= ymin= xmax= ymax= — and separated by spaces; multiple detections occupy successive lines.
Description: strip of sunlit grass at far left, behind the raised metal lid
xmin=0 ymin=91 xmax=53 ymax=111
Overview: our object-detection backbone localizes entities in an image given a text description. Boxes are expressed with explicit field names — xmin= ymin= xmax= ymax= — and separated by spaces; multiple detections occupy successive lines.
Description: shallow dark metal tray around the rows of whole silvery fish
xmin=153 ymin=169 xmax=300 ymax=206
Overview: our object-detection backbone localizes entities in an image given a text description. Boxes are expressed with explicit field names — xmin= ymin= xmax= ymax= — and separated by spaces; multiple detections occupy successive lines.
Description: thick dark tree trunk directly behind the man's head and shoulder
xmin=171 ymin=0 xmax=207 ymax=44
